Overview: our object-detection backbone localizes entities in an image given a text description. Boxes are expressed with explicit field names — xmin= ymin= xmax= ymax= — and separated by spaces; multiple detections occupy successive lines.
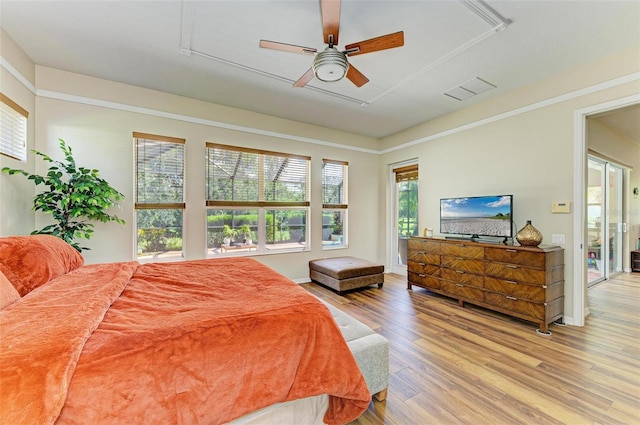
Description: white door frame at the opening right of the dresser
xmin=565 ymin=94 xmax=640 ymax=326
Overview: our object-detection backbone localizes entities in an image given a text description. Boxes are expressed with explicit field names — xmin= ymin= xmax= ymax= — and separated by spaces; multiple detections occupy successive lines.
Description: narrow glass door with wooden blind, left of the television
xmin=391 ymin=163 xmax=419 ymax=275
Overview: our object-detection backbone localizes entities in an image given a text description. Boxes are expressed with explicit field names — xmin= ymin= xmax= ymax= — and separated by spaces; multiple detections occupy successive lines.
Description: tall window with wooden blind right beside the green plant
xmin=133 ymin=133 xmax=185 ymax=259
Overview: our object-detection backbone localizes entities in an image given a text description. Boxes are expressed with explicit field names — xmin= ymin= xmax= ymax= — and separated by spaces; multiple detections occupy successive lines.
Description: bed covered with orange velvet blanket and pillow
xmin=0 ymin=235 xmax=371 ymax=424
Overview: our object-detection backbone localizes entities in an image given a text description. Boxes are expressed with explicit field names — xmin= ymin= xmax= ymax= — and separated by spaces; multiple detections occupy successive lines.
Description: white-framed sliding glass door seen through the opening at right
xmin=587 ymin=155 xmax=625 ymax=287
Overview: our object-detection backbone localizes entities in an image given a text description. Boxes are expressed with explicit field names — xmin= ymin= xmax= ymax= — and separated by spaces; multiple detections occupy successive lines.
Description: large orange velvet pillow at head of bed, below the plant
xmin=0 ymin=235 xmax=84 ymax=297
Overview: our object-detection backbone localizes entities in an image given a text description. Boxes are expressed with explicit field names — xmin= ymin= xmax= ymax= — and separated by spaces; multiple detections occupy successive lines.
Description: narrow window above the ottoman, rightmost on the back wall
xmin=322 ymin=159 xmax=349 ymax=249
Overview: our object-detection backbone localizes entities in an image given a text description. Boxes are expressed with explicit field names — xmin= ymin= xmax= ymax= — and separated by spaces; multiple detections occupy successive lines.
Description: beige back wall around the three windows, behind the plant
xmin=2 ymin=66 xmax=382 ymax=280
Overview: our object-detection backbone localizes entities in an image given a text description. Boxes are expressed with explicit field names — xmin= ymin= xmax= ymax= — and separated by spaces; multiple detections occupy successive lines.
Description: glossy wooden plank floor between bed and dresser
xmin=303 ymin=273 xmax=640 ymax=425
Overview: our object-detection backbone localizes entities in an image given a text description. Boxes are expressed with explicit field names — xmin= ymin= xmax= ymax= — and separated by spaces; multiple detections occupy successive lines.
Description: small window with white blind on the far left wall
xmin=0 ymin=93 xmax=29 ymax=161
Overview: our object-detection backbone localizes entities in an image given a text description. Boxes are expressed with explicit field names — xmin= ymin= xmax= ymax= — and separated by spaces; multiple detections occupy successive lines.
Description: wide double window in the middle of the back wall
xmin=206 ymin=143 xmax=311 ymax=255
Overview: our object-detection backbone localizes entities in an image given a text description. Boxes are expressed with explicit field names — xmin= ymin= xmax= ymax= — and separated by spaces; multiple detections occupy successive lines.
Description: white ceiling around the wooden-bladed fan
xmin=0 ymin=0 xmax=640 ymax=138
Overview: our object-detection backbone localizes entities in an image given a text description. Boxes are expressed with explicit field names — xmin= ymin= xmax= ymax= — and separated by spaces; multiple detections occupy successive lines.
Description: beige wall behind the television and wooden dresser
xmin=379 ymin=44 xmax=640 ymax=322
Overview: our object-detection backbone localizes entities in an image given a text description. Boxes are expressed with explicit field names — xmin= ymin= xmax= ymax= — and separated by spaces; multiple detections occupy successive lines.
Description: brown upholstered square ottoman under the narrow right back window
xmin=309 ymin=257 xmax=384 ymax=295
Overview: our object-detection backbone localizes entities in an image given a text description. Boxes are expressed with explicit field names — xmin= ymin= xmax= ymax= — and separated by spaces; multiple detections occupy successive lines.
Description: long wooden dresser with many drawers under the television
xmin=407 ymin=237 xmax=564 ymax=334
